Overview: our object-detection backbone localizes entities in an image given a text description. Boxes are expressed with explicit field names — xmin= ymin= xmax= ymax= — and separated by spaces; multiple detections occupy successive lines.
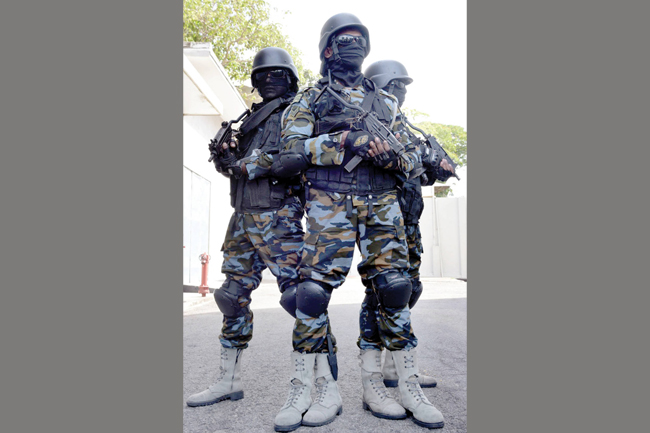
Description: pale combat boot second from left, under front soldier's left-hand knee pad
xmin=274 ymin=352 xmax=316 ymax=431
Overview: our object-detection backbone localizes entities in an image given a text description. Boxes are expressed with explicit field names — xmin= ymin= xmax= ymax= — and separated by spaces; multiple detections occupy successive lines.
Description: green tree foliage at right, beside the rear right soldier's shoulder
xmin=402 ymin=108 xmax=467 ymax=166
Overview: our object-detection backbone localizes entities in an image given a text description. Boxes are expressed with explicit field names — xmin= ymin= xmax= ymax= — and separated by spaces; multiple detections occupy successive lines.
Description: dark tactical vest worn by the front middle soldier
xmin=305 ymin=79 xmax=397 ymax=195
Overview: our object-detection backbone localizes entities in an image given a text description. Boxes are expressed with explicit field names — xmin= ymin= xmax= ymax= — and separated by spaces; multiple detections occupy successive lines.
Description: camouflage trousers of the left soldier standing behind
xmin=219 ymin=199 xmax=304 ymax=348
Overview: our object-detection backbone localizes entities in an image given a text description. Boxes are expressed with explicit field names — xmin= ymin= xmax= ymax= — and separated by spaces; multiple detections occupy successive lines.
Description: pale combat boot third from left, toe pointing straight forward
xmin=302 ymin=353 xmax=343 ymax=427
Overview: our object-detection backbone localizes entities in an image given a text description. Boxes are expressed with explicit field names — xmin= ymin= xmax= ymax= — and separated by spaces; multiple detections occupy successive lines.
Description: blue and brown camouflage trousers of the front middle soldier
xmin=293 ymin=188 xmax=417 ymax=353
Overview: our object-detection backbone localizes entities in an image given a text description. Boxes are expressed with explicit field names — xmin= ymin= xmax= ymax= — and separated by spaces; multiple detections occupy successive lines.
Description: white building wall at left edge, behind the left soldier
xmin=183 ymin=43 xmax=247 ymax=288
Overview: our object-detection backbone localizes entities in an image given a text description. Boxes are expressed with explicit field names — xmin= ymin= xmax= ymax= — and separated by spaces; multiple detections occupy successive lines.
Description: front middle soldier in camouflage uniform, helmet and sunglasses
xmin=268 ymin=13 xmax=443 ymax=431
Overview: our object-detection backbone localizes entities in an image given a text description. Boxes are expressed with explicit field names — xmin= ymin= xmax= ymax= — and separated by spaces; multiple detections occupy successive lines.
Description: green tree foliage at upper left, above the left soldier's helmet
xmin=183 ymin=0 xmax=317 ymax=94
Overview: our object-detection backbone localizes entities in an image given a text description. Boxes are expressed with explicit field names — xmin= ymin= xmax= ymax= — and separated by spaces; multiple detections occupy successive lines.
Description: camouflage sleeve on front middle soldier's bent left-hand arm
xmin=280 ymin=88 xmax=344 ymax=165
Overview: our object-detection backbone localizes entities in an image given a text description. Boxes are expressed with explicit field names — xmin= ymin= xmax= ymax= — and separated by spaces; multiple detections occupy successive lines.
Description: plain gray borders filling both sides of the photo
xmin=0 ymin=0 xmax=648 ymax=433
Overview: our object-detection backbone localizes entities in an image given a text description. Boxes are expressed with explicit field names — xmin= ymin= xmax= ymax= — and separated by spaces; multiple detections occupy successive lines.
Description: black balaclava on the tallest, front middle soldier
xmin=321 ymin=31 xmax=368 ymax=87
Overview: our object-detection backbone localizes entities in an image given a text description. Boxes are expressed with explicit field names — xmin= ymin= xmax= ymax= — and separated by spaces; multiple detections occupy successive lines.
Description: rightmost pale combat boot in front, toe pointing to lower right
xmin=392 ymin=349 xmax=445 ymax=428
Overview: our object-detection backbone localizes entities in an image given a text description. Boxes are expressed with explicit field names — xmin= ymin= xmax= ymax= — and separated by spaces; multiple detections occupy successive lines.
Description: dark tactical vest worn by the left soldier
xmin=230 ymin=94 xmax=300 ymax=213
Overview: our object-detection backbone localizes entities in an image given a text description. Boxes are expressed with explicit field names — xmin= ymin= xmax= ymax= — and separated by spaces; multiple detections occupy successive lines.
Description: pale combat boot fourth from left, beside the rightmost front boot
xmin=359 ymin=350 xmax=406 ymax=419
